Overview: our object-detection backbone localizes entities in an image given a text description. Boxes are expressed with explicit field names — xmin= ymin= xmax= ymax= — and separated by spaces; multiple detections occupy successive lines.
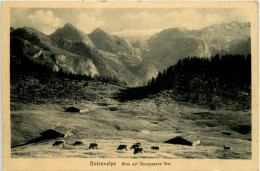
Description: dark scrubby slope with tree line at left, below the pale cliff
xmin=11 ymin=53 xmax=126 ymax=104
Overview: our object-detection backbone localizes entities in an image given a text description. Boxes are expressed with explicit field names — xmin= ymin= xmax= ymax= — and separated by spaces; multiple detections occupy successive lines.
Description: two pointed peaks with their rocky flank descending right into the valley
xmin=51 ymin=25 xmax=142 ymax=82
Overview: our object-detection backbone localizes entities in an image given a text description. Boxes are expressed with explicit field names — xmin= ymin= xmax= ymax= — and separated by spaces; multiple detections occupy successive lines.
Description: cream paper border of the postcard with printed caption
xmin=1 ymin=1 xmax=259 ymax=171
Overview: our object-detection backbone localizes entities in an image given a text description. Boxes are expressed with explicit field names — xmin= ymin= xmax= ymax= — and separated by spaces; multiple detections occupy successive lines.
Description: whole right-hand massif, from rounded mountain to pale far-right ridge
xmin=143 ymin=22 xmax=251 ymax=71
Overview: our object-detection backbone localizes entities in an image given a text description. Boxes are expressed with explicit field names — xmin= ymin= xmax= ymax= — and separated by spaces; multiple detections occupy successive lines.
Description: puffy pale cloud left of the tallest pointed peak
xmin=27 ymin=10 xmax=62 ymax=34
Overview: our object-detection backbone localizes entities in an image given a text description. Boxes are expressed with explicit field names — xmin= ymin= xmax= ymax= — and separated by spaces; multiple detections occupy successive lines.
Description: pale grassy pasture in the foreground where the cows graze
xmin=11 ymin=90 xmax=251 ymax=159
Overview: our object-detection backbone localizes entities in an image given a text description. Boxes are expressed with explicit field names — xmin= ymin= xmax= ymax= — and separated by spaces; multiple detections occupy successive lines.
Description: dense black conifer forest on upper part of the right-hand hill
xmin=147 ymin=54 xmax=251 ymax=93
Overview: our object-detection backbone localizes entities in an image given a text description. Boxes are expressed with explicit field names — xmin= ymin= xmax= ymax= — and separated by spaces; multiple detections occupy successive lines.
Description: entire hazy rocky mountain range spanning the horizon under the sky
xmin=10 ymin=22 xmax=251 ymax=86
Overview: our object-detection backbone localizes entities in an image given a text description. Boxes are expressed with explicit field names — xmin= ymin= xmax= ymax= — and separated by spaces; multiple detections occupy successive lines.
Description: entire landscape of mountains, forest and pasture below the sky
xmin=10 ymin=22 xmax=252 ymax=159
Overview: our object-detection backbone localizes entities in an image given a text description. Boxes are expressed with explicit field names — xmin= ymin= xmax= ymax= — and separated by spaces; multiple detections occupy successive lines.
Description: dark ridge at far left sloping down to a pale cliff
xmin=11 ymin=29 xmax=99 ymax=76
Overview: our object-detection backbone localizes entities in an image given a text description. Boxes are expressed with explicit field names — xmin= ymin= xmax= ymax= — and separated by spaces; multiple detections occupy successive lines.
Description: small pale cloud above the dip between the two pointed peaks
xmin=76 ymin=12 xmax=104 ymax=33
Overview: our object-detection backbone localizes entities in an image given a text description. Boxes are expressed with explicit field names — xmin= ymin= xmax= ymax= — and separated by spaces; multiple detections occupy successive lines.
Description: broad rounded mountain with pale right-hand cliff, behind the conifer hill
xmin=147 ymin=29 xmax=210 ymax=71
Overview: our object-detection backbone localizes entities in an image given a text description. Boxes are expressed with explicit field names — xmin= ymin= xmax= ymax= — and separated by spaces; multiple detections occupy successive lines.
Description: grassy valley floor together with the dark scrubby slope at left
xmin=11 ymin=26 xmax=251 ymax=159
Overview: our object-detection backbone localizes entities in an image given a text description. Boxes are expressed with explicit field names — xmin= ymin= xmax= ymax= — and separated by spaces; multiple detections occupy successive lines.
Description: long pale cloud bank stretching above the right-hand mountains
xmin=104 ymin=8 xmax=250 ymax=36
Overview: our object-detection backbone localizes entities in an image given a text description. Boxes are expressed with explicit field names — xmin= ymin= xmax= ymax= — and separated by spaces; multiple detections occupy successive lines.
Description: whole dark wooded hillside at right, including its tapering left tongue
xmin=115 ymin=55 xmax=251 ymax=109
